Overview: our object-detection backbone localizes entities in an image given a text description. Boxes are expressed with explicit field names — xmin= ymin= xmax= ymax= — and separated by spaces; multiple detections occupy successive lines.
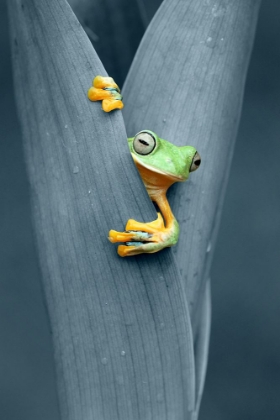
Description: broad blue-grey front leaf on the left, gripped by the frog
xmin=9 ymin=0 xmax=194 ymax=420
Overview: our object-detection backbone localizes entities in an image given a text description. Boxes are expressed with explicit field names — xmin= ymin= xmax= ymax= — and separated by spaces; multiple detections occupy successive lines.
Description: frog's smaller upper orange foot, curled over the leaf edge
xmin=88 ymin=76 xmax=123 ymax=112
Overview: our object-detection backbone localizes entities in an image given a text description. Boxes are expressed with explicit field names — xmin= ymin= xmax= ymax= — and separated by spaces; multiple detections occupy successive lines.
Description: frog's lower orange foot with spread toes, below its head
xmin=108 ymin=213 xmax=179 ymax=257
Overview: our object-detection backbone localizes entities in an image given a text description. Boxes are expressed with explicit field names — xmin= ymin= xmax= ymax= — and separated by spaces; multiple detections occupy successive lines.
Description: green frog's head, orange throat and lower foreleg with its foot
xmin=109 ymin=130 xmax=201 ymax=257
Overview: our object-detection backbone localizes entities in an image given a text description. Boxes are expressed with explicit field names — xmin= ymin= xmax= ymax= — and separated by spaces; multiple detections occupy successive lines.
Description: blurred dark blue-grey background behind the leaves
xmin=0 ymin=0 xmax=280 ymax=420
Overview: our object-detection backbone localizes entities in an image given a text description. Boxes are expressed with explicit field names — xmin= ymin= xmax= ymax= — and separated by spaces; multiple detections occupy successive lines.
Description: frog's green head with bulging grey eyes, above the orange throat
xmin=128 ymin=130 xmax=201 ymax=182
